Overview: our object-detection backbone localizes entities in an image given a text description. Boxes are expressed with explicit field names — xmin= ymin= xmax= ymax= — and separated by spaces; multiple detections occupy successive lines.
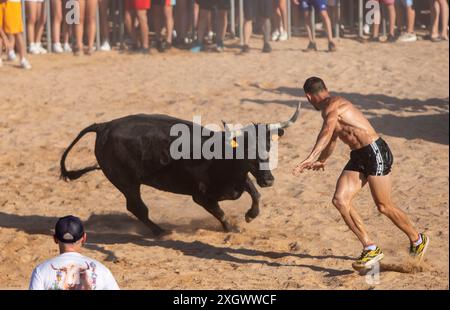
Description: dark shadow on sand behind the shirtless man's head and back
xmin=241 ymin=84 xmax=449 ymax=145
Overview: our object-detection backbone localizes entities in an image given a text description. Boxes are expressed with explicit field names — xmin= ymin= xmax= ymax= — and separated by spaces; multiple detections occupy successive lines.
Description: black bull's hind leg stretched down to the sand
xmin=123 ymin=185 xmax=168 ymax=236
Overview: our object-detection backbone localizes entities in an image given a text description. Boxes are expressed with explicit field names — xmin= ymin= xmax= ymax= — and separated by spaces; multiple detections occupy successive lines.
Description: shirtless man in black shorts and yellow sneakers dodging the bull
xmin=293 ymin=77 xmax=430 ymax=269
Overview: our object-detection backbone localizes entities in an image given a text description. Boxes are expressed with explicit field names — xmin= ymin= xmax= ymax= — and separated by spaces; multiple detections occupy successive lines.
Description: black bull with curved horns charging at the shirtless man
xmin=61 ymin=104 xmax=300 ymax=235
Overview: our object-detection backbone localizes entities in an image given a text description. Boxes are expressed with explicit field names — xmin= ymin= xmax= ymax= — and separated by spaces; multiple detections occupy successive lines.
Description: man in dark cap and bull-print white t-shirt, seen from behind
xmin=29 ymin=215 xmax=119 ymax=290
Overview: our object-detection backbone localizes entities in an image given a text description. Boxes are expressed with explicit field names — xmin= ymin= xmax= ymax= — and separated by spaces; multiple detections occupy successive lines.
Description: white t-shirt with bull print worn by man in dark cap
xmin=29 ymin=252 xmax=119 ymax=290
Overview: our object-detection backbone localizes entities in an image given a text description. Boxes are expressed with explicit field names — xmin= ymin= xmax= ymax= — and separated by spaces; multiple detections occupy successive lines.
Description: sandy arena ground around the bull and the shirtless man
xmin=0 ymin=39 xmax=449 ymax=289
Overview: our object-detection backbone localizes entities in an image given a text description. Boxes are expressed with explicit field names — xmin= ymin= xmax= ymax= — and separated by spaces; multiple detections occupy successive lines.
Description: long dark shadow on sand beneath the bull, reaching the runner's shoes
xmin=0 ymin=212 xmax=354 ymax=277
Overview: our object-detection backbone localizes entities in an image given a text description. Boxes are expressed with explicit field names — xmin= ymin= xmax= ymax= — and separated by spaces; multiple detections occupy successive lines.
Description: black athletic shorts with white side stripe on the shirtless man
xmin=344 ymin=138 xmax=394 ymax=177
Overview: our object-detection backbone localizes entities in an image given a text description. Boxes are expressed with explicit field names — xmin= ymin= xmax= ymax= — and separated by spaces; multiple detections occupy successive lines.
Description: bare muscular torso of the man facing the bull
xmin=322 ymin=97 xmax=378 ymax=150
